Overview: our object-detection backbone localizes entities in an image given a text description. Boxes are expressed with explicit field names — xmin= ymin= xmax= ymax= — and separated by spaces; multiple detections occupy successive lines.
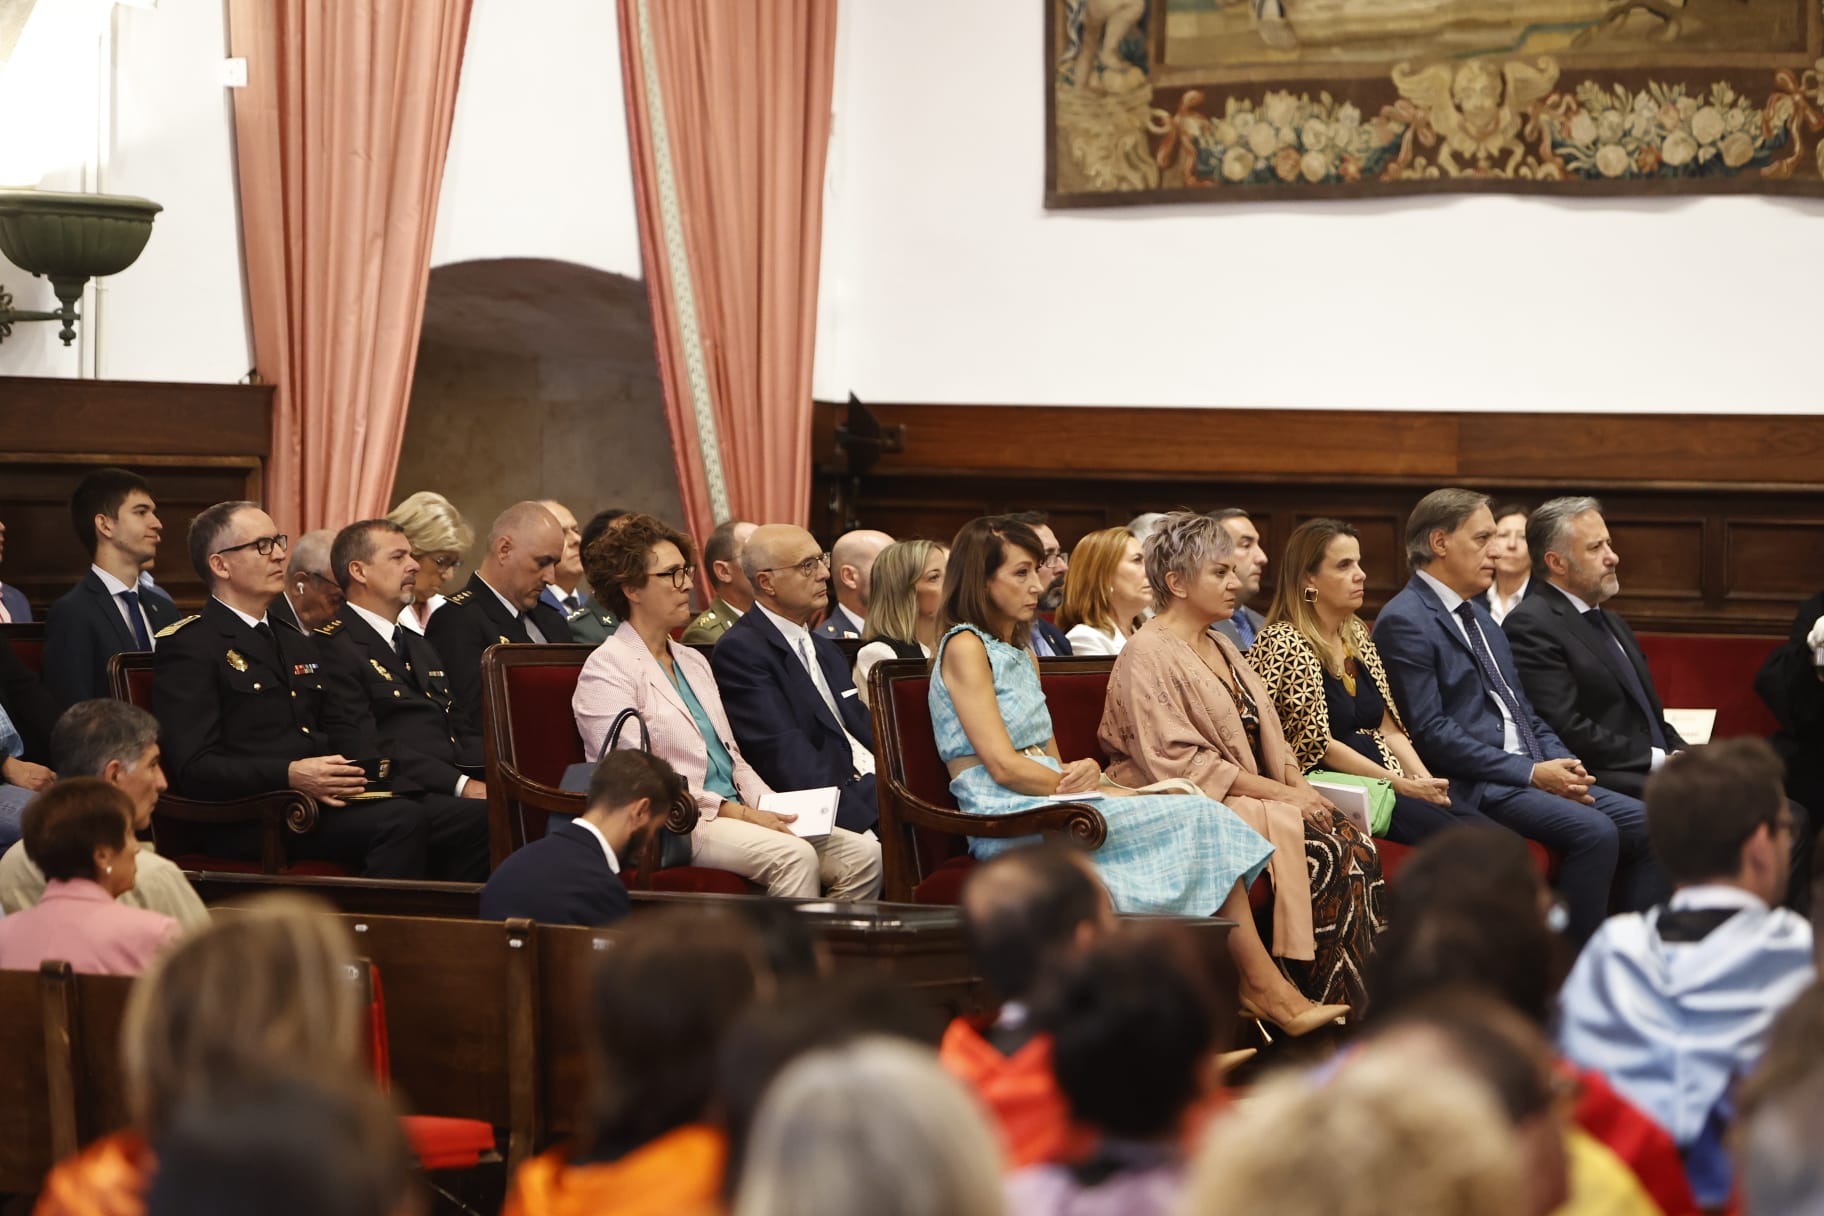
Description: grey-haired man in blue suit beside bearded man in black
xmin=1373 ymin=489 xmax=1671 ymax=943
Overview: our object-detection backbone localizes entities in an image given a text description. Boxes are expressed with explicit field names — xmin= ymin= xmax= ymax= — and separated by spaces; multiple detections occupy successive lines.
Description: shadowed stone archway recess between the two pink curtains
xmin=392 ymin=259 xmax=684 ymax=538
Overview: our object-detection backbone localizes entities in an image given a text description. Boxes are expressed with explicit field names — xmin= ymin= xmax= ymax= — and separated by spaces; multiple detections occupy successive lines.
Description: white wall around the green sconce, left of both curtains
xmin=0 ymin=0 xmax=254 ymax=383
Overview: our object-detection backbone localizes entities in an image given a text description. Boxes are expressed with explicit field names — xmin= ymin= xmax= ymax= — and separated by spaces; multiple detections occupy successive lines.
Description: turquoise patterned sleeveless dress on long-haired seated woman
xmin=930 ymin=625 xmax=1273 ymax=917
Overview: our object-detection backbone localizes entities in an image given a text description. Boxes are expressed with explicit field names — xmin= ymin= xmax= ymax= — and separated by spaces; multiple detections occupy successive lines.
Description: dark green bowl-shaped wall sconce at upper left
xmin=0 ymin=190 xmax=164 ymax=346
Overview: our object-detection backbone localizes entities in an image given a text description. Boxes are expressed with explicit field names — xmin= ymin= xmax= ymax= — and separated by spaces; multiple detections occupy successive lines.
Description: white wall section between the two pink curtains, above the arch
xmin=430 ymin=0 xmax=640 ymax=279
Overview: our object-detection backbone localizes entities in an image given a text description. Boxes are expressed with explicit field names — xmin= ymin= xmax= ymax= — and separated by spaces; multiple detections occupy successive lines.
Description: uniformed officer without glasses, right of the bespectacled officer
xmin=317 ymin=520 xmax=487 ymax=882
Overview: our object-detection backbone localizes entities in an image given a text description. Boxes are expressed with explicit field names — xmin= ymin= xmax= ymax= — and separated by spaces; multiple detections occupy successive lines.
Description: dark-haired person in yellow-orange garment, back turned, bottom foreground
xmin=502 ymin=911 xmax=772 ymax=1216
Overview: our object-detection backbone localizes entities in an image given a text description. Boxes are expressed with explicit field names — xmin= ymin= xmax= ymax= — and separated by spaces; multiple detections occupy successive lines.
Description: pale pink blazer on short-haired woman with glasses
xmin=571 ymin=622 xmax=773 ymax=820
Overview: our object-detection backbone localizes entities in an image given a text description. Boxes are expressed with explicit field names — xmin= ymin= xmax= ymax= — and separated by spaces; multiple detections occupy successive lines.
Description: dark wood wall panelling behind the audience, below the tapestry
xmin=814 ymin=403 xmax=1824 ymax=634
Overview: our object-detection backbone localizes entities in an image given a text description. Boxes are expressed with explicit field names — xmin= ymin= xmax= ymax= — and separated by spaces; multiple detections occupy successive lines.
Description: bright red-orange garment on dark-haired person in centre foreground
xmin=938 ymin=1017 xmax=1094 ymax=1169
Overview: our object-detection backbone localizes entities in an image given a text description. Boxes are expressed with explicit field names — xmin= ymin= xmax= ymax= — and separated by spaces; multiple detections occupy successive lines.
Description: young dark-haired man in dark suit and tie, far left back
xmin=42 ymin=469 xmax=182 ymax=709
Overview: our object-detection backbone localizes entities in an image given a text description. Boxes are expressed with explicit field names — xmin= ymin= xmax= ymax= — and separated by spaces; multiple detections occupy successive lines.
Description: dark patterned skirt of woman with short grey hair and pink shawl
xmin=1268 ymin=820 xmax=1386 ymax=1014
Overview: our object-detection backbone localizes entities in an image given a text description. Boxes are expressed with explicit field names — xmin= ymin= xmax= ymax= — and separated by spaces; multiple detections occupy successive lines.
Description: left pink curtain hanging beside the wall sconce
xmin=228 ymin=0 xmax=471 ymax=534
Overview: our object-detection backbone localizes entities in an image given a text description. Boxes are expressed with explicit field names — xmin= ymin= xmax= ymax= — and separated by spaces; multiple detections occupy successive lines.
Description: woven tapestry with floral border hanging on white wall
xmin=1043 ymin=0 xmax=1824 ymax=208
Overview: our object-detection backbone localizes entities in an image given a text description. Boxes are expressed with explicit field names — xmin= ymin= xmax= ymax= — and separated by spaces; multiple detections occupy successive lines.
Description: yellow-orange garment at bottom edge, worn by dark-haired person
xmin=500 ymin=1123 xmax=728 ymax=1216
